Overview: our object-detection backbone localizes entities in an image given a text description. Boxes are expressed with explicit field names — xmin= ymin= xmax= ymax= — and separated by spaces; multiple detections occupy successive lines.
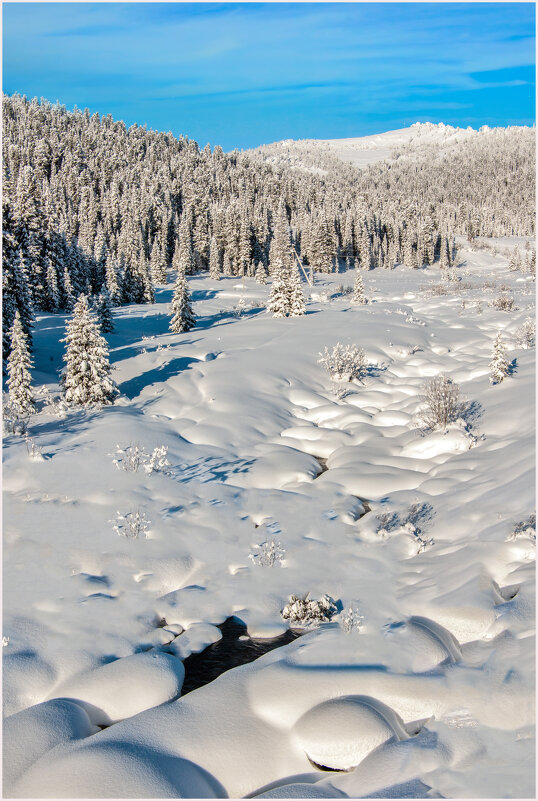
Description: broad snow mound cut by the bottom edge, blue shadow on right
xmin=13 ymin=741 xmax=227 ymax=798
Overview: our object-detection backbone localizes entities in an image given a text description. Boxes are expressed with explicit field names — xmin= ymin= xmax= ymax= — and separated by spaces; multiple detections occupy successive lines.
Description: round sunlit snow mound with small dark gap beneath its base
xmin=292 ymin=695 xmax=408 ymax=770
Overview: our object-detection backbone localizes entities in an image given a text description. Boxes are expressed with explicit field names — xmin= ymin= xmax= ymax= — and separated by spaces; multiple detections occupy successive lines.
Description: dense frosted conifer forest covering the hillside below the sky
xmin=3 ymin=95 xmax=534 ymax=357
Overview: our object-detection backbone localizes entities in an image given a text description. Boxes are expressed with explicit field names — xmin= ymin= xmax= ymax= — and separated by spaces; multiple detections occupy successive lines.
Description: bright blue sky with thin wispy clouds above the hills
xmin=3 ymin=2 xmax=535 ymax=150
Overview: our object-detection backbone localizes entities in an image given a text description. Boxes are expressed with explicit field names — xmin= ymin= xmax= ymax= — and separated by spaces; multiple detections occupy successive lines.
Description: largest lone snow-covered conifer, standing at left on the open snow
xmin=61 ymin=295 xmax=118 ymax=406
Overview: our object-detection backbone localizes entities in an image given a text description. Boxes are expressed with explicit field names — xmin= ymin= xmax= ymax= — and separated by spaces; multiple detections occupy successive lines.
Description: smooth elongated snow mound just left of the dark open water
xmin=48 ymin=652 xmax=185 ymax=725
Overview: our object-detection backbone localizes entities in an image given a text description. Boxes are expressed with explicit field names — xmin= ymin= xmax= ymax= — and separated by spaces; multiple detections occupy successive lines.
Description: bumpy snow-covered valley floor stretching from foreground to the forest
xmin=3 ymin=247 xmax=535 ymax=798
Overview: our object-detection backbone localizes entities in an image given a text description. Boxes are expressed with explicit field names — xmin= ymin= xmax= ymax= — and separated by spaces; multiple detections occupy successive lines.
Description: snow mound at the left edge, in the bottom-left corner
xmin=3 ymin=698 xmax=98 ymax=795
